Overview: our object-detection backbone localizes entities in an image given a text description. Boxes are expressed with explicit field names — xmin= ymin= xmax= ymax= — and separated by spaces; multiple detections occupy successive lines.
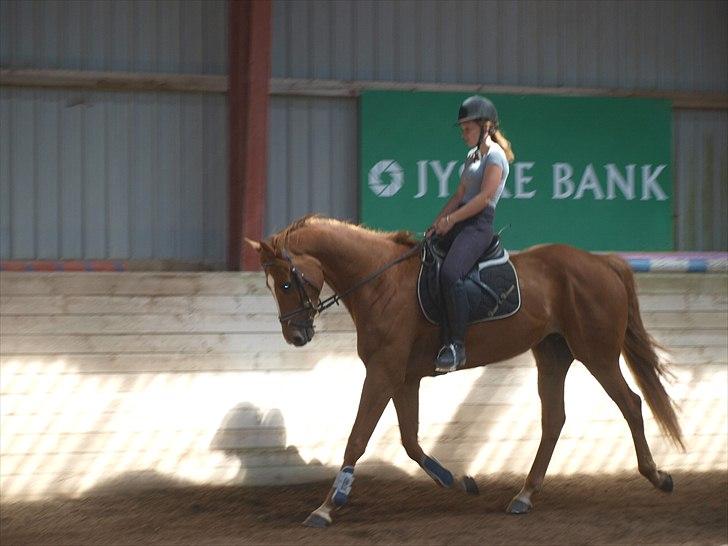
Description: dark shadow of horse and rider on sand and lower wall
xmin=79 ymin=402 xmax=516 ymax=525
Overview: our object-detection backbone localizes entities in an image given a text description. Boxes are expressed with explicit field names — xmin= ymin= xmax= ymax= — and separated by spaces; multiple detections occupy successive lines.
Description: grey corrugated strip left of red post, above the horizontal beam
xmin=0 ymin=0 xmax=227 ymax=74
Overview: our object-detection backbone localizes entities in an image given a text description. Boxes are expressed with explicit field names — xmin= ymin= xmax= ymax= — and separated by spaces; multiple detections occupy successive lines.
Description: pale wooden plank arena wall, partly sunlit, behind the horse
xmin=0 ymin=273 xmax=728 ymax=499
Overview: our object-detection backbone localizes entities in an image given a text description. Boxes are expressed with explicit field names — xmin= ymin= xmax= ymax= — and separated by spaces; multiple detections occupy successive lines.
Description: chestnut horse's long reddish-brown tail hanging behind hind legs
xmin=608 ymin=255 xmax=685 ymax=450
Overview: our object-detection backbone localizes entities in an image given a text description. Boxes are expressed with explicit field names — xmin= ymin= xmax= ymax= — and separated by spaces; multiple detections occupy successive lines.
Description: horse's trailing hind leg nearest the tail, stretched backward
xmin=584 ymin=356 xmax=673 ymax=493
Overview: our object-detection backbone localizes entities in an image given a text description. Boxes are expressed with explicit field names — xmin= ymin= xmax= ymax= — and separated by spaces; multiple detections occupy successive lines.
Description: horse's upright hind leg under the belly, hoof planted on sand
xmin=507 ymin=335 xmax=574 ymax=514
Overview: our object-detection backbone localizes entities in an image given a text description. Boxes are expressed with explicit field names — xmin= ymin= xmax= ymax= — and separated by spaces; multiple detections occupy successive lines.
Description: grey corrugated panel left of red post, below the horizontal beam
xmin=0 ymin=88 xmax=227 ymax=267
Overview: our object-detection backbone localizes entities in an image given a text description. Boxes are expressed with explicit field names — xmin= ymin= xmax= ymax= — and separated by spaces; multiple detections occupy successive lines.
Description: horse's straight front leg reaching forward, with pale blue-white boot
xmin=303 ymin=370 xmax=394 ymax=527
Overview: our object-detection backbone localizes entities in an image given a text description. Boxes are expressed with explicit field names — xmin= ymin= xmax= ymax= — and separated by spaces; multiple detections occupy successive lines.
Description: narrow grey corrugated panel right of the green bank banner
xmin=674 ymin=111 xmax=728 ymax=250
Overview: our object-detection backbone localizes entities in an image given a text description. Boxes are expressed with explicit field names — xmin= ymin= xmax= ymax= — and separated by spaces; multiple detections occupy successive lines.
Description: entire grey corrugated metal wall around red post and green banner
xmin=0 ymin=0 xmax=728 ymax=258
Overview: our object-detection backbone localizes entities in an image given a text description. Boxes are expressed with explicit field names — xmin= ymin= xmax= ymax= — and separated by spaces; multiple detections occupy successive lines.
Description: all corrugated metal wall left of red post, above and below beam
xmin=0 ymin=0 xmax=227 ymax=268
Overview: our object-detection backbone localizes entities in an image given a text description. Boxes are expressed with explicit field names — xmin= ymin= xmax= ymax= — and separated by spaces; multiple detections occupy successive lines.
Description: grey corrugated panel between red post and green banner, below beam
xmin=265 ymin=97 xmax=359 ymax=235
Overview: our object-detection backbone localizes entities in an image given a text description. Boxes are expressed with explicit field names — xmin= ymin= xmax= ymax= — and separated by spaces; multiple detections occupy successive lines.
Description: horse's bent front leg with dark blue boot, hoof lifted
xmin=393 ymin=379 xmax=478 ymax=495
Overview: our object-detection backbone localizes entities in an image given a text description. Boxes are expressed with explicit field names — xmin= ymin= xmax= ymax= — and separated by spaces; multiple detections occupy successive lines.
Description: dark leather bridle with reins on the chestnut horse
xmin=262 ymin=242 xmax=422 ymax=328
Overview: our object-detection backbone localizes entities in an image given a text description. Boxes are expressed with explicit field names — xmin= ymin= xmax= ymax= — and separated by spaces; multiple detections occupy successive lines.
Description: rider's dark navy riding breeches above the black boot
xmin=440 ymin=207 xmax=495 ymax=289
